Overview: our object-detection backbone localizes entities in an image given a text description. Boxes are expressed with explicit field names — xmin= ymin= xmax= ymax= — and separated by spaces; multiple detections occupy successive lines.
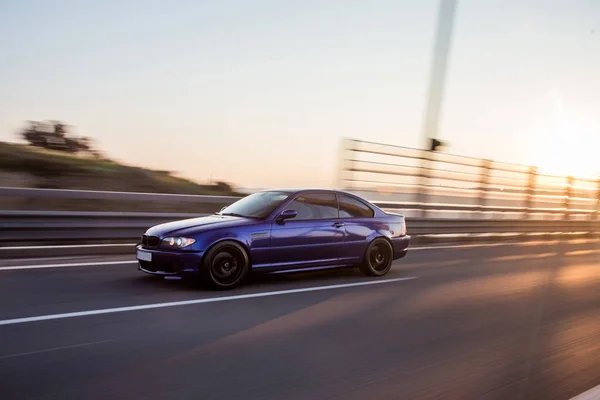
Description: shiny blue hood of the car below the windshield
xmin=146 ymin=215 xmax=255 ymax=237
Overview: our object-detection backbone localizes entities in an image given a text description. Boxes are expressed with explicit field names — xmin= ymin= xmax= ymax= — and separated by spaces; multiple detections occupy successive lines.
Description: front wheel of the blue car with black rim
xmin=202 ymin=241 xmax=250 ymax=290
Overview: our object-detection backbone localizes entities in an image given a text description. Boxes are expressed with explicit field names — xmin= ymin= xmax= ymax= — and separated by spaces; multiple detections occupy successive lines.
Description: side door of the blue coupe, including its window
xmin=270 ymin=192 xmax=346 ymax=268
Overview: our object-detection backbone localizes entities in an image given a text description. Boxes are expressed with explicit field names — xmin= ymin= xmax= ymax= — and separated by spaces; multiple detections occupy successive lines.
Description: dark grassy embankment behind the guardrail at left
xmin=0 ymin=142 xmax=237 ymax=212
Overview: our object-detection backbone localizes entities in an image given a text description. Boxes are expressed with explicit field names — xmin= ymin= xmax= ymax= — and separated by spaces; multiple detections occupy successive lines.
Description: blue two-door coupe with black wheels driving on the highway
xmin=136 ymin=190 xmax=410 ymax=289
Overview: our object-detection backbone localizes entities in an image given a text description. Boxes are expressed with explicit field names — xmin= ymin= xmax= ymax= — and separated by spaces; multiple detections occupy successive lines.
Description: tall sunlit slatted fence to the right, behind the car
xmin=338 ymin=139 xmax=600 ymax=220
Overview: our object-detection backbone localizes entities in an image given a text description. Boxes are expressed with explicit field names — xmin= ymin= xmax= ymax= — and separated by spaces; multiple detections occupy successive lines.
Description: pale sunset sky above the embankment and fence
xmin=0 ymin=0 xmax=600 ymax=188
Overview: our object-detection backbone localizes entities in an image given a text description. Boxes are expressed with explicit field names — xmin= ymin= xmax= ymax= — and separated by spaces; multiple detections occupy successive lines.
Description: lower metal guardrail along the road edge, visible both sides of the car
xmin=0 ymin=211 xmax=600 ymax=245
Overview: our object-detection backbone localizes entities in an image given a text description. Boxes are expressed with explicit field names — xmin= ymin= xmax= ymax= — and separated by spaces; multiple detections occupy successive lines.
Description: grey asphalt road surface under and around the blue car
xmin=0 ymin=242 xmax=600 ymax=400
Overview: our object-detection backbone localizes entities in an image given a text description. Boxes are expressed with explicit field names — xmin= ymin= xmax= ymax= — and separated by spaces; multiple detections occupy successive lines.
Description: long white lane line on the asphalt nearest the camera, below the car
xmin=0 ymin=276 xmax=418 ymax=325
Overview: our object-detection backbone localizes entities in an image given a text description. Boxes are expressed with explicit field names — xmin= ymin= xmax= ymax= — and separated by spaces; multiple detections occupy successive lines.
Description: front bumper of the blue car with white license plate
xmin=136 ymin=245 xmax=204 ymax=276
